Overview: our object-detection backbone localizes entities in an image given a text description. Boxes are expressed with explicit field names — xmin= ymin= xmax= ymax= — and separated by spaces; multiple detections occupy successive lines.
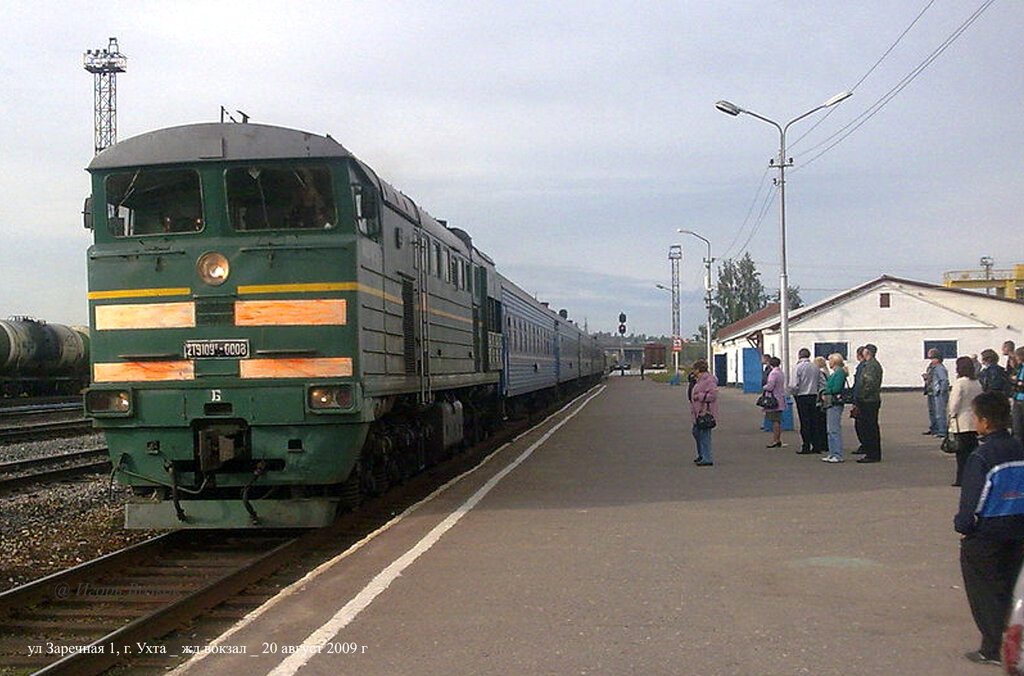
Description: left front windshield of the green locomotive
xmin=105 ymin=169 xmax=203 ymax=237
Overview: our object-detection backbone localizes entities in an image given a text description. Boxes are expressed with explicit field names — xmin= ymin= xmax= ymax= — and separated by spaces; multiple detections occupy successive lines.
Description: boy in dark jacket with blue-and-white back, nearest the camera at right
xmin=953 ymin=392 xmax=1024 ymax=664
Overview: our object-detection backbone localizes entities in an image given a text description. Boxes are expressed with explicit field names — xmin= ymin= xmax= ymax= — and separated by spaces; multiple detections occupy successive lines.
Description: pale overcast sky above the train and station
xmin=0 ymin=0 xmax=1024 ymax=335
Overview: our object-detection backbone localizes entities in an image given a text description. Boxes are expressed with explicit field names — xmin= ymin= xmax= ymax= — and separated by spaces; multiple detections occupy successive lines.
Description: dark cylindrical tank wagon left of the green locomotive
xmin=0 ymin=316 xmax=89 ymax=396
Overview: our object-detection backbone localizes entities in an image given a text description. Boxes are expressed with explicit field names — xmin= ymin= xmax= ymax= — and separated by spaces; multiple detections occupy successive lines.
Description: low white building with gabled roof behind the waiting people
xmin=716 ymin=276 xmax=1024 ymax=390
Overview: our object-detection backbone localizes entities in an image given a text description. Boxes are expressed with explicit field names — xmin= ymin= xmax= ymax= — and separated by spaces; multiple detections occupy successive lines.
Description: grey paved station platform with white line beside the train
xmin=175 ymin=378 xmax=996 ymax=676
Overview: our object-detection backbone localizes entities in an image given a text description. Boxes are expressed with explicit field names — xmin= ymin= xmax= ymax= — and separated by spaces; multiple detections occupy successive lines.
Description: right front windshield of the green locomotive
xmin=224 ymin=165 xmax=336 ymax=230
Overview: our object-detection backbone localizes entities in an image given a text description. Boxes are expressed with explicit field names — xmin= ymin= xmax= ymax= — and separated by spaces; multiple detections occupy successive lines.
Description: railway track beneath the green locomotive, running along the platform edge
xmin=0 ymin=387 xmax=593 ymax=676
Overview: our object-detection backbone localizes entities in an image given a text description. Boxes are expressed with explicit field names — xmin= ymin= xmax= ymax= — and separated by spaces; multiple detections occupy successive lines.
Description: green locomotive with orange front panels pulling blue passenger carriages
xmin=85 ymin=124 xmax=603 ymax=527
